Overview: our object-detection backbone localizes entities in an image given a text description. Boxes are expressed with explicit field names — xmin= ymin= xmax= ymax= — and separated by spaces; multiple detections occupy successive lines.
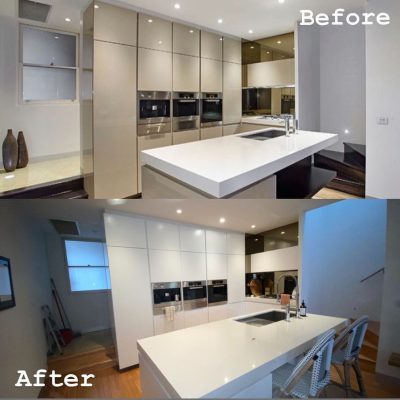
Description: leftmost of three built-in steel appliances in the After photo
xmin=152 ymin=282 xmax=182 ymax=315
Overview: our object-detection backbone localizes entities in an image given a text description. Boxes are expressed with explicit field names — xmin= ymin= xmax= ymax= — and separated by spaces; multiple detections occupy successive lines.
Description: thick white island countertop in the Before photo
xmin=141 ymin=131 xmax=338 ymax=198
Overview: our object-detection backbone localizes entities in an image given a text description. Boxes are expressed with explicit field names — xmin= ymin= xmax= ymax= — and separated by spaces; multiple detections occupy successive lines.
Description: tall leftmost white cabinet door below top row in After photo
xmin=108 ymin=247 xmax=154 ymax=369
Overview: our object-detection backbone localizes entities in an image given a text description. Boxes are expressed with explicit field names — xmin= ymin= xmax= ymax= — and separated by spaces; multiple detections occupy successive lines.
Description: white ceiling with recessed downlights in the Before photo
xmin=111 ymin=0 xmax=366 ymax=40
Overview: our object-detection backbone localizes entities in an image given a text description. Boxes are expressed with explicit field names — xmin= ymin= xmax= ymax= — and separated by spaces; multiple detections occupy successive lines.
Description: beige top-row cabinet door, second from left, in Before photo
xmin=138 ymin=14 xmax=172 ymax=52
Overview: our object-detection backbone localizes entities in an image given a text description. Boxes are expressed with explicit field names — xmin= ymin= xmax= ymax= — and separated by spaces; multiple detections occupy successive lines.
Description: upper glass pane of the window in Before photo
xmin=22 ymin=26 xmax=76 ymax=67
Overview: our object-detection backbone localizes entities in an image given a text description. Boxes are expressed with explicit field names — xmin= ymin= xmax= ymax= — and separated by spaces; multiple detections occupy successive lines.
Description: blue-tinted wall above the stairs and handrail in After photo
xmin=301 ymin=200 xmax=387 ymax=321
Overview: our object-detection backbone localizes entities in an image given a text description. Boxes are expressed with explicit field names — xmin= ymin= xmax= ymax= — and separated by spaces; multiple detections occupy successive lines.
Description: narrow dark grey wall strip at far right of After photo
xmin=376 ymin=200 xmax=400 ymax=378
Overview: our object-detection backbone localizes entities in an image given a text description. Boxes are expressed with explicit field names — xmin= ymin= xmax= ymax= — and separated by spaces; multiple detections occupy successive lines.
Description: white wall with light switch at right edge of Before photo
xmin=366 ymin=0 xmax=400 ymax=199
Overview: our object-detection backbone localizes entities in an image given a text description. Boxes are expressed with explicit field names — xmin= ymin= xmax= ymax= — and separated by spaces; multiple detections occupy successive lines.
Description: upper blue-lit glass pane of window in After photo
xmin=65 ymin=240 xmax=108 ymax=267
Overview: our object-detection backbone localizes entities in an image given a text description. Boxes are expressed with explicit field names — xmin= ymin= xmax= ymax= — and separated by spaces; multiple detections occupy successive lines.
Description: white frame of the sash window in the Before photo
xmin=17 ymin=22 xmax=80 ymax=106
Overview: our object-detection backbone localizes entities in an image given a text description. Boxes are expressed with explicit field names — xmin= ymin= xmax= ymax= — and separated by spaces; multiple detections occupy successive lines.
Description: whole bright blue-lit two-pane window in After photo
xmin=64 ymin=240 xmax=111 ymax=292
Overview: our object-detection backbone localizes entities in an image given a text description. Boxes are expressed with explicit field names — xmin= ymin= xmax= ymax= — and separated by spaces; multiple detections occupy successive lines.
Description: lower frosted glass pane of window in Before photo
xmin=23 ymin=67 xmax=76 ymax=101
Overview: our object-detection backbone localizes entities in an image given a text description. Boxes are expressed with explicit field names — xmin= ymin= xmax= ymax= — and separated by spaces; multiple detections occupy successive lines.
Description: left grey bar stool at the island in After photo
xmin=272 ymin=329 xmax=336 ymax=399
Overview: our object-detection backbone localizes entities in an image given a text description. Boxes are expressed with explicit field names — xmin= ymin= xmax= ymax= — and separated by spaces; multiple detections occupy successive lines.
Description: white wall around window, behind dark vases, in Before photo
xmin=0 ymin=0 xmax=80 ymax=163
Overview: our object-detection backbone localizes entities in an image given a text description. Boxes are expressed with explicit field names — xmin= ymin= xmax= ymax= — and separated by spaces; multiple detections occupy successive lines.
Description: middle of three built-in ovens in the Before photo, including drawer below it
xmin=172 ymin=93 xmax=200 ymax=132
